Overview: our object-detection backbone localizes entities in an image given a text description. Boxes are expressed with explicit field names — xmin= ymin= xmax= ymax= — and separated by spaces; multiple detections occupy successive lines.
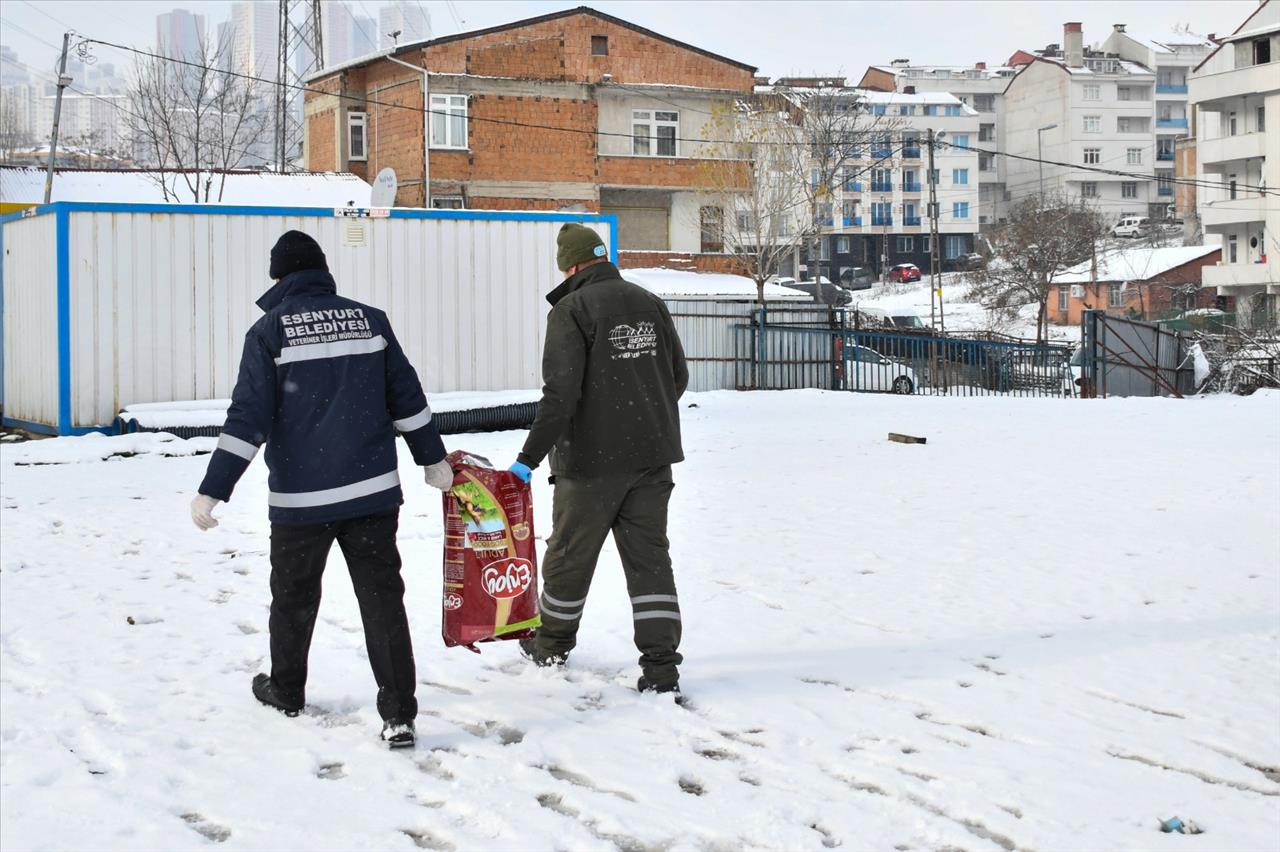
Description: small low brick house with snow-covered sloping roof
xmin=1048 ymin=246 xmax=1230 ymax=325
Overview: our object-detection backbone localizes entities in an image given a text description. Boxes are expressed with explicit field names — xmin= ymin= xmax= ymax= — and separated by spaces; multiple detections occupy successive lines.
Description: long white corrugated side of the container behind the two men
xmin=52 ymin=211 xmax=611 ymax=426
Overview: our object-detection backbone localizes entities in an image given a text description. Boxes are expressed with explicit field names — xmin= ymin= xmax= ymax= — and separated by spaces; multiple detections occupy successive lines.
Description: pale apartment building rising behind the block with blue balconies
xmin=859 ymin=59 xmax=1018 ymax=228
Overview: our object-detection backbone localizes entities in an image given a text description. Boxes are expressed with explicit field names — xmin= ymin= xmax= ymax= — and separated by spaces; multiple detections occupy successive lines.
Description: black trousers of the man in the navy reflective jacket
xmin=270 ymin=510 xmax=417 ymax=720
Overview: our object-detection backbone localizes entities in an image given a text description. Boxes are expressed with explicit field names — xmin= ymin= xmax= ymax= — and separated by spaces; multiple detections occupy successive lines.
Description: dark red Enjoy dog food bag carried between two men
xmin=442 ymin=452 xmax=541 ymax=654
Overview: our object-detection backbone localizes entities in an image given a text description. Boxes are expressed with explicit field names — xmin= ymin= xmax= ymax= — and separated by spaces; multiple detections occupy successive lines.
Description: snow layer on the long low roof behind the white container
xmin=0 ymin=166 xmax=372 ymax=207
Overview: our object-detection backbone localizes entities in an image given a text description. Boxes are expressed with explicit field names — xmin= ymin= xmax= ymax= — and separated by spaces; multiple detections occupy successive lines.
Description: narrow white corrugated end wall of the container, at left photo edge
xmin=3 ymin=216 xmax=58 ymax=425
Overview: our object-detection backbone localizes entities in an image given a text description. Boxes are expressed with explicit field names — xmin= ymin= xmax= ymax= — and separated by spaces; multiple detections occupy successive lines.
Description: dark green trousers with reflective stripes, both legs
xmin=538 ymin=464 xmax=684 ymax=686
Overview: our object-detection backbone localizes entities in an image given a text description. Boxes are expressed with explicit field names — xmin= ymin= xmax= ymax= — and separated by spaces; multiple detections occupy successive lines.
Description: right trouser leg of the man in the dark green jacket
xmin=613 ymin=466 xmax=684 ymax=684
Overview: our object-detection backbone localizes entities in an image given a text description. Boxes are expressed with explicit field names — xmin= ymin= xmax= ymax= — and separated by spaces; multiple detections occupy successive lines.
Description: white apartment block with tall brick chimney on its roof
xmin=1005 ymin=23 xmax=1174 ymax=220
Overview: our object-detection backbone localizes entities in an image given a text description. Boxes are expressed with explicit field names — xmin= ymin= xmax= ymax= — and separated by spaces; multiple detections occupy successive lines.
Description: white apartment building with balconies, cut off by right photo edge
xmin=1189 ymin=0 xmax=1280 ymax=327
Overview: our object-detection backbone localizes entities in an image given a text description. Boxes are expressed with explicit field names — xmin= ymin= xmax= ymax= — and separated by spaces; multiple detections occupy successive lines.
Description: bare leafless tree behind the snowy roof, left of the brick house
xmin=127 ymin=32 xmax=270 ymax=203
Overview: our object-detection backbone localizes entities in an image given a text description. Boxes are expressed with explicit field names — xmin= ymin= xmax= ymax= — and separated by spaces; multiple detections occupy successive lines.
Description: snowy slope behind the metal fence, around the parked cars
xmin=854 ymin=272 xmax=1080 ymax=343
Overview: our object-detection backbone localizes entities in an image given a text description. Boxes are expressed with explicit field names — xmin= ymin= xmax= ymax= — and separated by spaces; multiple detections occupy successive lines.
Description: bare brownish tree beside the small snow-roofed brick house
xmin=969 ymin=194 xmax=1106 ymax=343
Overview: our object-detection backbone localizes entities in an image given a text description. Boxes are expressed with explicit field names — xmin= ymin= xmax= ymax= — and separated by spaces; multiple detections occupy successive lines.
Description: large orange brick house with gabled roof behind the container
xmin=305 ymin=6 xmax=755 ymax=253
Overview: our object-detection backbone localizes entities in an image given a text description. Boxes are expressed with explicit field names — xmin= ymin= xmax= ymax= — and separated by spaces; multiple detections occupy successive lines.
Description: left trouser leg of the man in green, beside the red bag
xmin=538 ymin=476 xmax=627 ymax=654
